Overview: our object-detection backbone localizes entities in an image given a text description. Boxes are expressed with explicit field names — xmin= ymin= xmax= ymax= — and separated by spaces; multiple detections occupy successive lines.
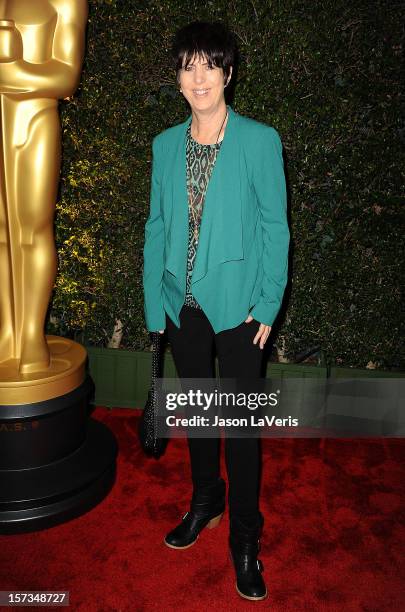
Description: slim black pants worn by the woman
xmin=166 ymin=305 xmax=263 ymax=523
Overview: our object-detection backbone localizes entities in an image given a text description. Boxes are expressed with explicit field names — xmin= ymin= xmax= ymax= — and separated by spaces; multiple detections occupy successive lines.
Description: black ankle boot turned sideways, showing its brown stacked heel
xmin=164 ymin=478 xmax=225 ymax=548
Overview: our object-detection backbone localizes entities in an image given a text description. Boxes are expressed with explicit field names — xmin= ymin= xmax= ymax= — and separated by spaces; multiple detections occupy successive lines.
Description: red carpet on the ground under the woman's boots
xmin=0 ymin=408 xmax=405 ymax=612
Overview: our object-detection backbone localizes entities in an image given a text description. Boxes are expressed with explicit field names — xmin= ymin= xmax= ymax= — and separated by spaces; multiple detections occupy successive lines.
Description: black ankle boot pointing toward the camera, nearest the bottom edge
xmin=229 ymin=513 xmax=267 ymax=601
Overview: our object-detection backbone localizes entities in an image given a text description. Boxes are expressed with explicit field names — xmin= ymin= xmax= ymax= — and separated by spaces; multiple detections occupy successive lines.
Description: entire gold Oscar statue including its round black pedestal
xmin=0 ymin=0 xmax=118 ymax=534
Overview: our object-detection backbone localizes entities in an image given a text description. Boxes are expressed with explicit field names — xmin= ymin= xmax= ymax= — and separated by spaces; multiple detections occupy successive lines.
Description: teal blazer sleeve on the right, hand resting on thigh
xmin=250 ymin=126 xmax=290 ymax=325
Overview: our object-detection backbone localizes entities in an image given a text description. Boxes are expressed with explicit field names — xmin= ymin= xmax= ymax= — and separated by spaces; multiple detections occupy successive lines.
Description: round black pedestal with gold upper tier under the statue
xmin=0 ymin=336 xmax=117 ymax=534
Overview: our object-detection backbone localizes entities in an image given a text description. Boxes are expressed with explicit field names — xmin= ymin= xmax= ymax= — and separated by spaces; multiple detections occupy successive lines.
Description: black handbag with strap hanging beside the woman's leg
xmin=138 ymin=332 xmax=167 ymax=458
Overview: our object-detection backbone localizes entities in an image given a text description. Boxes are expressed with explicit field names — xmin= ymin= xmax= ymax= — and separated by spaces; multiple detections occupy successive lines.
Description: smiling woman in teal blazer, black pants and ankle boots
xmin=143 ymin=22 xmax=289 ymax=600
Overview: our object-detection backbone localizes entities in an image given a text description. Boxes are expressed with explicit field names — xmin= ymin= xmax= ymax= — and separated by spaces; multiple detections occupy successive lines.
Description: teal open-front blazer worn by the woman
xmin=143 ymin=106 xmax=290 ymax=333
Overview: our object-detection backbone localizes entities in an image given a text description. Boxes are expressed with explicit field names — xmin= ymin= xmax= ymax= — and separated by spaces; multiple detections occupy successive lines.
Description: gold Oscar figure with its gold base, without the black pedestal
xmin=0 ymin=0 xmax=88 ymax=404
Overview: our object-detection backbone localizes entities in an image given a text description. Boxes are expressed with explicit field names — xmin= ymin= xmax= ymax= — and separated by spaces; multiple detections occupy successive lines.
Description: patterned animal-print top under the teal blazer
xmin=184 ymin=124 xmax=222 ymax=309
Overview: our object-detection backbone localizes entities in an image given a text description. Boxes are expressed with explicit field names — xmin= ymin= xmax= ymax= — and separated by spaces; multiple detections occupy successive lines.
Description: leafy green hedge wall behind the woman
xmin=47 ymin=0 xmax=405 ymax=368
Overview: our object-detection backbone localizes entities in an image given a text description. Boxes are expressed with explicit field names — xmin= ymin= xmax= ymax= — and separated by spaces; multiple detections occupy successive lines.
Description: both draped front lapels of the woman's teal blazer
xmin=162 ymin=106 xmax=244 ymax=284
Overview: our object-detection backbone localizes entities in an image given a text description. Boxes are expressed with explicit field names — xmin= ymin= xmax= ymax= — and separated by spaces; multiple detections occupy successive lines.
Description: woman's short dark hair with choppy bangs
xmin=172 ymin=21 xmax=237 ymax=81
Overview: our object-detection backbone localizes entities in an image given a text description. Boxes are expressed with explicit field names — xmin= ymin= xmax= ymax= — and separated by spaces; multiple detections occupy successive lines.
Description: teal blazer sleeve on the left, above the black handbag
xmin=143 ymin=137 xmax=166 ymax=331
